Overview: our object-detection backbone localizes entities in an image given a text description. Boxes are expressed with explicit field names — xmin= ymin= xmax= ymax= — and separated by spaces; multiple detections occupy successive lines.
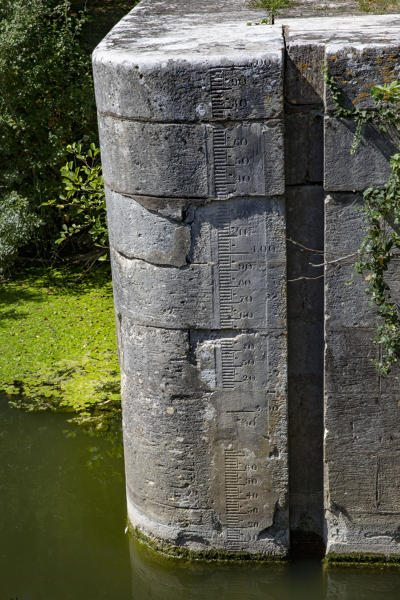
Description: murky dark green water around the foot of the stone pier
xmin=0 ymin=398 xmax=400 ymax=600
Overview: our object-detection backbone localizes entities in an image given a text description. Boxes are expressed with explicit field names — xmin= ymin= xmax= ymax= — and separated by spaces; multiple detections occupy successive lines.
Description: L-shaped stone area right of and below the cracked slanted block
xmin=112 ymin=198 xmax=285 ymax=329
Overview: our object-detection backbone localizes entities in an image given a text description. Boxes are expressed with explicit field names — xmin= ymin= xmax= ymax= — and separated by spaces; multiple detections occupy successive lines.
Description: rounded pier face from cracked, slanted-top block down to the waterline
xmin=107 ymin=192 xmax=289 ymax=556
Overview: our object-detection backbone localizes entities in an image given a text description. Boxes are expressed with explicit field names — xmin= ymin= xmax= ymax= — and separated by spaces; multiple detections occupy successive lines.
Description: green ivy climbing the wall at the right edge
xmin=325 ymin=72 xmax=400 ymax=375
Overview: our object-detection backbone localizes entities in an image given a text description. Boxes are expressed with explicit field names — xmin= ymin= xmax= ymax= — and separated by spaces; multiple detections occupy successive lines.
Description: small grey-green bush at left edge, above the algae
xmin=0 ymin=192 xmax=41 ymax=276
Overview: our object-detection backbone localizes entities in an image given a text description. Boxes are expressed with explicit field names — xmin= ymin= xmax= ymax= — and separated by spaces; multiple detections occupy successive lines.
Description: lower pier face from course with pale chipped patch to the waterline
xmin=119 ymin=317 xmax=288 ymax=555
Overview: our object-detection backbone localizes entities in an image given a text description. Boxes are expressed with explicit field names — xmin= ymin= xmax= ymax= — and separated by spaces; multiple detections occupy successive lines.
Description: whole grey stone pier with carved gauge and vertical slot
xmin=93 ymin=0 xmax=400 ymax=558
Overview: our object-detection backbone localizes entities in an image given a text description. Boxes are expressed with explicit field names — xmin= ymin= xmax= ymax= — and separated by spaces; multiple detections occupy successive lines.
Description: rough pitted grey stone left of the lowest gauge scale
xmin=122 ymin=384 xmax=210 ymax=529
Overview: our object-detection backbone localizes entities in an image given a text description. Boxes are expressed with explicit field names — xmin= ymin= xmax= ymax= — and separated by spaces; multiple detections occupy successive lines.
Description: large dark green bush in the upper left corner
xmin=0 ymin=0 xmax=97 ymax=262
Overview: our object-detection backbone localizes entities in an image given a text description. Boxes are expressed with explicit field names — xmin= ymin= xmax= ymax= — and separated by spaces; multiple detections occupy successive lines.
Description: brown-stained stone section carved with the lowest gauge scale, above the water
xmin=211 ymin=392 xmax=288 ymax=555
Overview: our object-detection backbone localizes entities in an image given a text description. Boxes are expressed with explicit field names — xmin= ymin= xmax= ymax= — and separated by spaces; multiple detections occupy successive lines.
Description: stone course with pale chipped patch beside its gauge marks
xmin=120 ymin=317 xmax=286 ymax=399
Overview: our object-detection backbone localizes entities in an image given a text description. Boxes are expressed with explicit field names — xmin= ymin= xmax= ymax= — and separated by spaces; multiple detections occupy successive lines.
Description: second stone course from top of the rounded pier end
xmin=99 ymin=117 xmax=284 ymax=198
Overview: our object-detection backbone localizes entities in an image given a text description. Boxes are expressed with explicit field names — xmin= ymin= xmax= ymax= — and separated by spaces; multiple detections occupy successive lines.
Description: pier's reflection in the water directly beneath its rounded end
xmin=130 ymin=541 xmax=324 ymax=600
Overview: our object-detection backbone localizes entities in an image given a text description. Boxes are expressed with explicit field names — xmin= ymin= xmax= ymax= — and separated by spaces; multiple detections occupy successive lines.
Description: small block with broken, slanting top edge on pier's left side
xmin=106 ymin=189 xmax=191 ymax=267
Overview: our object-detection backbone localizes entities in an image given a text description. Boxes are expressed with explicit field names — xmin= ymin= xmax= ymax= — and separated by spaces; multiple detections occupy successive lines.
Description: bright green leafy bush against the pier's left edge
xmin=46 ymin=143 xmax=108 ymax=249
